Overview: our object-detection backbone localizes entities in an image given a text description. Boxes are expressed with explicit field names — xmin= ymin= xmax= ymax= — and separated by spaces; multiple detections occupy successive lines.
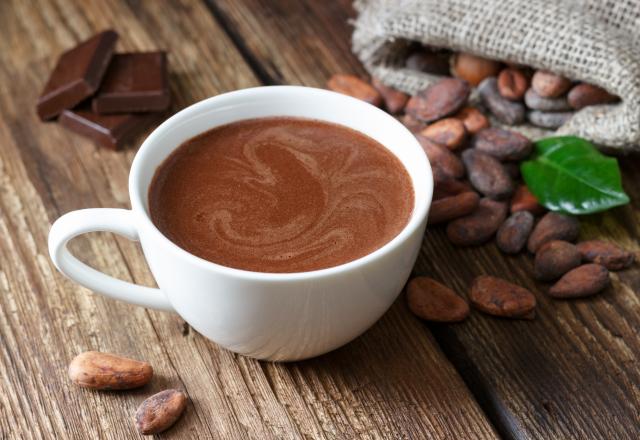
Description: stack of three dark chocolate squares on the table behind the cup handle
xmin=37 ymin=30 xmax=171 ymax=150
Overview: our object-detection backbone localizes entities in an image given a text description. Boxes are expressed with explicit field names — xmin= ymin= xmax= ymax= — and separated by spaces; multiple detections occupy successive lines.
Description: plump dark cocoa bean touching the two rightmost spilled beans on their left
xmin=533 ymin=240 xmax=581 ymax=281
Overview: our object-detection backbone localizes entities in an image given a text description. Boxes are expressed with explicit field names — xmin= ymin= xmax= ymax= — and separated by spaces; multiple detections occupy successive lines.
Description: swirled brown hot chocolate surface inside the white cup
xmin=149 ymin=117 xmax=414 ymax=273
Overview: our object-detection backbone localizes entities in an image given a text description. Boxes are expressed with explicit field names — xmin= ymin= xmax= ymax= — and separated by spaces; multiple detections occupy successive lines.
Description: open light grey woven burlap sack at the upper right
xmin=353 ymin=0 xmax=640 ymax=151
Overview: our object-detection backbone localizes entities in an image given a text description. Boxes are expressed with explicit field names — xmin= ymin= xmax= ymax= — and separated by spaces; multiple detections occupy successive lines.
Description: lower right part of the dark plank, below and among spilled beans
xmin=416 ymin=166 xmax=640 ymax=439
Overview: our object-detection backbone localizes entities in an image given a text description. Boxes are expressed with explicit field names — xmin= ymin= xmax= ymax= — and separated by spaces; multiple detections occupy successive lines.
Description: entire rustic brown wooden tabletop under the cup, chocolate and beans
xmin=0 ymin=0 xmax=640 ymax=439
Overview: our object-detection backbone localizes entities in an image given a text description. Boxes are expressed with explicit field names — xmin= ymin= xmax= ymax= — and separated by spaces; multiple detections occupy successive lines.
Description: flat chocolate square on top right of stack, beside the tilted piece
xmin=92 ymin=52 xmax=170 ymax=114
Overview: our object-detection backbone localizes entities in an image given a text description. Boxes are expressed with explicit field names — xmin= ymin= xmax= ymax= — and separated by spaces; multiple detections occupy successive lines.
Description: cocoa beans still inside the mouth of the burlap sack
xmin=405 ymin=46 xmax=619 ymax=129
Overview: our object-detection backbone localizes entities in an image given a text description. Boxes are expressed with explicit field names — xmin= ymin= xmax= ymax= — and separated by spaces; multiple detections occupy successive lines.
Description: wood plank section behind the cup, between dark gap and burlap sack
xmin=206 ymin=0 xmax=365 ymax=88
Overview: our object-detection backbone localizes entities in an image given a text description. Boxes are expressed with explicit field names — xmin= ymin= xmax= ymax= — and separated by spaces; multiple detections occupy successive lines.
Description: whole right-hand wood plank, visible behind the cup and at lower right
xmin=209 ymin=0 xmax=640 ymax=438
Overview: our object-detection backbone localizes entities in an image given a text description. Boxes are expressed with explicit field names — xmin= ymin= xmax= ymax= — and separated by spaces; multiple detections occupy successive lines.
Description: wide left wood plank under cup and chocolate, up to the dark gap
xmin=0 ymin=0 xmax=496 ymax=439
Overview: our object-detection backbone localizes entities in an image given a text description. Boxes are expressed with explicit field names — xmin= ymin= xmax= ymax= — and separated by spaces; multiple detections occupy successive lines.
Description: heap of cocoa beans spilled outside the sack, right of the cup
xmin=328 ymin=70 xmax=634 ymax=322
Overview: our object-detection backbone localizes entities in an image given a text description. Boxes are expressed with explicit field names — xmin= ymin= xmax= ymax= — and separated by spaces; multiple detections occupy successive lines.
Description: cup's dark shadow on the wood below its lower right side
xmin=272 ymin=297 xmax=476 ymax=421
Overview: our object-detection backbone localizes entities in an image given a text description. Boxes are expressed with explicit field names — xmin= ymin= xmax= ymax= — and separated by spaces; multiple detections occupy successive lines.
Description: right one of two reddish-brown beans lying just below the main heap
xmin=469 ymin=275 xmax=536 ymax=319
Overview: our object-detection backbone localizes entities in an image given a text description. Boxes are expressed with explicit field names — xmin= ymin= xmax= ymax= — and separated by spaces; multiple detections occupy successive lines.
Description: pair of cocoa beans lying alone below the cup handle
xmin=69 ymin=351 xmax=187 ymax=435
